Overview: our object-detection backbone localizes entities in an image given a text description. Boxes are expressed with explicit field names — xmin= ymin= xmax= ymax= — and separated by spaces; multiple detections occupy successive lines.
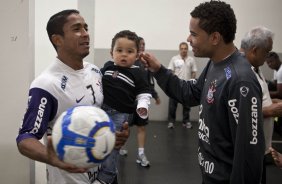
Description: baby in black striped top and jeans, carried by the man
xmin=94 ymin=30 xmax=152 ymax=184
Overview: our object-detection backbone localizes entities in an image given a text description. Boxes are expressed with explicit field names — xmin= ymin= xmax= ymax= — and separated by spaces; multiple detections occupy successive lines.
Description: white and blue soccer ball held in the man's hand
xmin=52 ymin=106 xmax=115 ymax=168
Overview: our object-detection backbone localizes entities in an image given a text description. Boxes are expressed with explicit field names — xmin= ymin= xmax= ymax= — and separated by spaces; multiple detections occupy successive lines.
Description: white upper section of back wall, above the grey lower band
xmin=94 ymin=0 xmax=282 ymax=52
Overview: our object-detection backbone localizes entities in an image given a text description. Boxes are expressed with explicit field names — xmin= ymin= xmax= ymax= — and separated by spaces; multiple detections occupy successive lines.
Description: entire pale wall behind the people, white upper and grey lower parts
xmin=0 ymin=0 xmax=282 ymax=184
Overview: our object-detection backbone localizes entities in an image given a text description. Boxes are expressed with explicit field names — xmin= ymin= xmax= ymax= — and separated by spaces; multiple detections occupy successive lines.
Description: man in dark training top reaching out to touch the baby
xmin=142 ymin=1 xmax=265 ymax=184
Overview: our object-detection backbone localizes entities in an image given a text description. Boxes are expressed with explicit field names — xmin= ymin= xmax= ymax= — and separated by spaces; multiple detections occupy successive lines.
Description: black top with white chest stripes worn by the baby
xmin=101 ymin=61 xmax=151 ymax=113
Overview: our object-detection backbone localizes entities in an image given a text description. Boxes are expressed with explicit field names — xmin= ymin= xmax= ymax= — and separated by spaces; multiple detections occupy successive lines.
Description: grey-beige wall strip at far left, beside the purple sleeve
xmin=0 ymin=0 xmax=34 ymax=184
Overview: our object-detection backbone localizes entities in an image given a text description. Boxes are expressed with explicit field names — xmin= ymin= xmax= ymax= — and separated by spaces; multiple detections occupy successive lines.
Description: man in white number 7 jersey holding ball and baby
xmin=17 ymin=10 xmax=129 ymax=184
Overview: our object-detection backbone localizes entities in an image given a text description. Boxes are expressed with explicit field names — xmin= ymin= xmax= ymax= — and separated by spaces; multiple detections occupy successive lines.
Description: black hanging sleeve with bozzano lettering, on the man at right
xmin=228 ymin=82 xmax=265 ymax=184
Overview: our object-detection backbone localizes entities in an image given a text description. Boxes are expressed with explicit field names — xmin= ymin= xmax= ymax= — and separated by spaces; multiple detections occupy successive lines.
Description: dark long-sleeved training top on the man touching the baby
xmin=154 ymin=51 xmax=265 ymax=184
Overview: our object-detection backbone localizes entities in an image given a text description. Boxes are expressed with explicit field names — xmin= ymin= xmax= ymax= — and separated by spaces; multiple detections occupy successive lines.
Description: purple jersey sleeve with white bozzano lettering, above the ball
xmin=16 ymin=88 xmax=58 ymax=143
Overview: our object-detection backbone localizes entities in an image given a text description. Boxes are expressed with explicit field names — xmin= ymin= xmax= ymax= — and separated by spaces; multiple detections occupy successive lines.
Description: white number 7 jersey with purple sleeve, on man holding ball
xmin=17 ymin=59 xmax=103 ymax=184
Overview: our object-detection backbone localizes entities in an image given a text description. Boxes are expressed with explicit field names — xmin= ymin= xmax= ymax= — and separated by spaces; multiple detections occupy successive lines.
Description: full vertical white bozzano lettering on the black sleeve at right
xmin=250 ymin=97 xmax=258 ymax=144
